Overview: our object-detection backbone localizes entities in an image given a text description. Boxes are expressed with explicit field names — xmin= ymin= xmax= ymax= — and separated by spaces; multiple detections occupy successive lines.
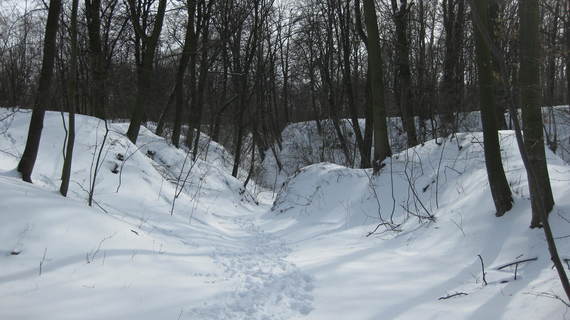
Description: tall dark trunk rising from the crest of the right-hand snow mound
xmin=364 ymin=0 xmax=391 ymax=173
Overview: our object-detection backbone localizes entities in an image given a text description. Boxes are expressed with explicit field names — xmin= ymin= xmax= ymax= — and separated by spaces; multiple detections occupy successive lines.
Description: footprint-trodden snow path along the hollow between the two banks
xmin=186 ymin=211 xmax=313 ymax=320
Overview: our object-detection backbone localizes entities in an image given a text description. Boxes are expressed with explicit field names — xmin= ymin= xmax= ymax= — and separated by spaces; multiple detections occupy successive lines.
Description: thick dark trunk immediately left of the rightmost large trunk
xmin=471 ymin=0 xmax=513 ymax=217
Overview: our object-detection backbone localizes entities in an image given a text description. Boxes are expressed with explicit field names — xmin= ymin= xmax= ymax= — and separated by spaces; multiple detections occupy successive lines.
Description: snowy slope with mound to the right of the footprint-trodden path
xmin=264 ymin=131 xmax=570 ymax=319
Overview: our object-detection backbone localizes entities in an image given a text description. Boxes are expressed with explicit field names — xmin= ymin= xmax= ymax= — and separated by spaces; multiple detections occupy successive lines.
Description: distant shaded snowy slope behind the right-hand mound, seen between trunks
xmin=258 ymin=105 xmax=570 ymax=187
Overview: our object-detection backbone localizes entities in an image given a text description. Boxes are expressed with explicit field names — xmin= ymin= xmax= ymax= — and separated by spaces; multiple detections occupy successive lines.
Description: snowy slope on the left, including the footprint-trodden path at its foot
xmin=0 ymin=109 xmax=311 ymax=319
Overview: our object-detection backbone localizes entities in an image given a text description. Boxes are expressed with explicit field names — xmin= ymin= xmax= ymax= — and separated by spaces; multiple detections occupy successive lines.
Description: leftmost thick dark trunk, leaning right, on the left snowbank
xmin=18 ymin=0 xmax=61 ymax=183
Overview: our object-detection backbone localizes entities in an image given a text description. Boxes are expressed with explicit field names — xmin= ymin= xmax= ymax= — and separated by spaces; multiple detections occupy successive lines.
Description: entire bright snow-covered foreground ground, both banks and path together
xmin=0 ymin=109 xmax=570 ymax=320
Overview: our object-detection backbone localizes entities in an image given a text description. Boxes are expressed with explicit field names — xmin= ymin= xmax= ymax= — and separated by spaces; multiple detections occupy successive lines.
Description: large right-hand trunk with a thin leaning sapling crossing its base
xmin=519 ymin=0 xmax=554 ymax=228
